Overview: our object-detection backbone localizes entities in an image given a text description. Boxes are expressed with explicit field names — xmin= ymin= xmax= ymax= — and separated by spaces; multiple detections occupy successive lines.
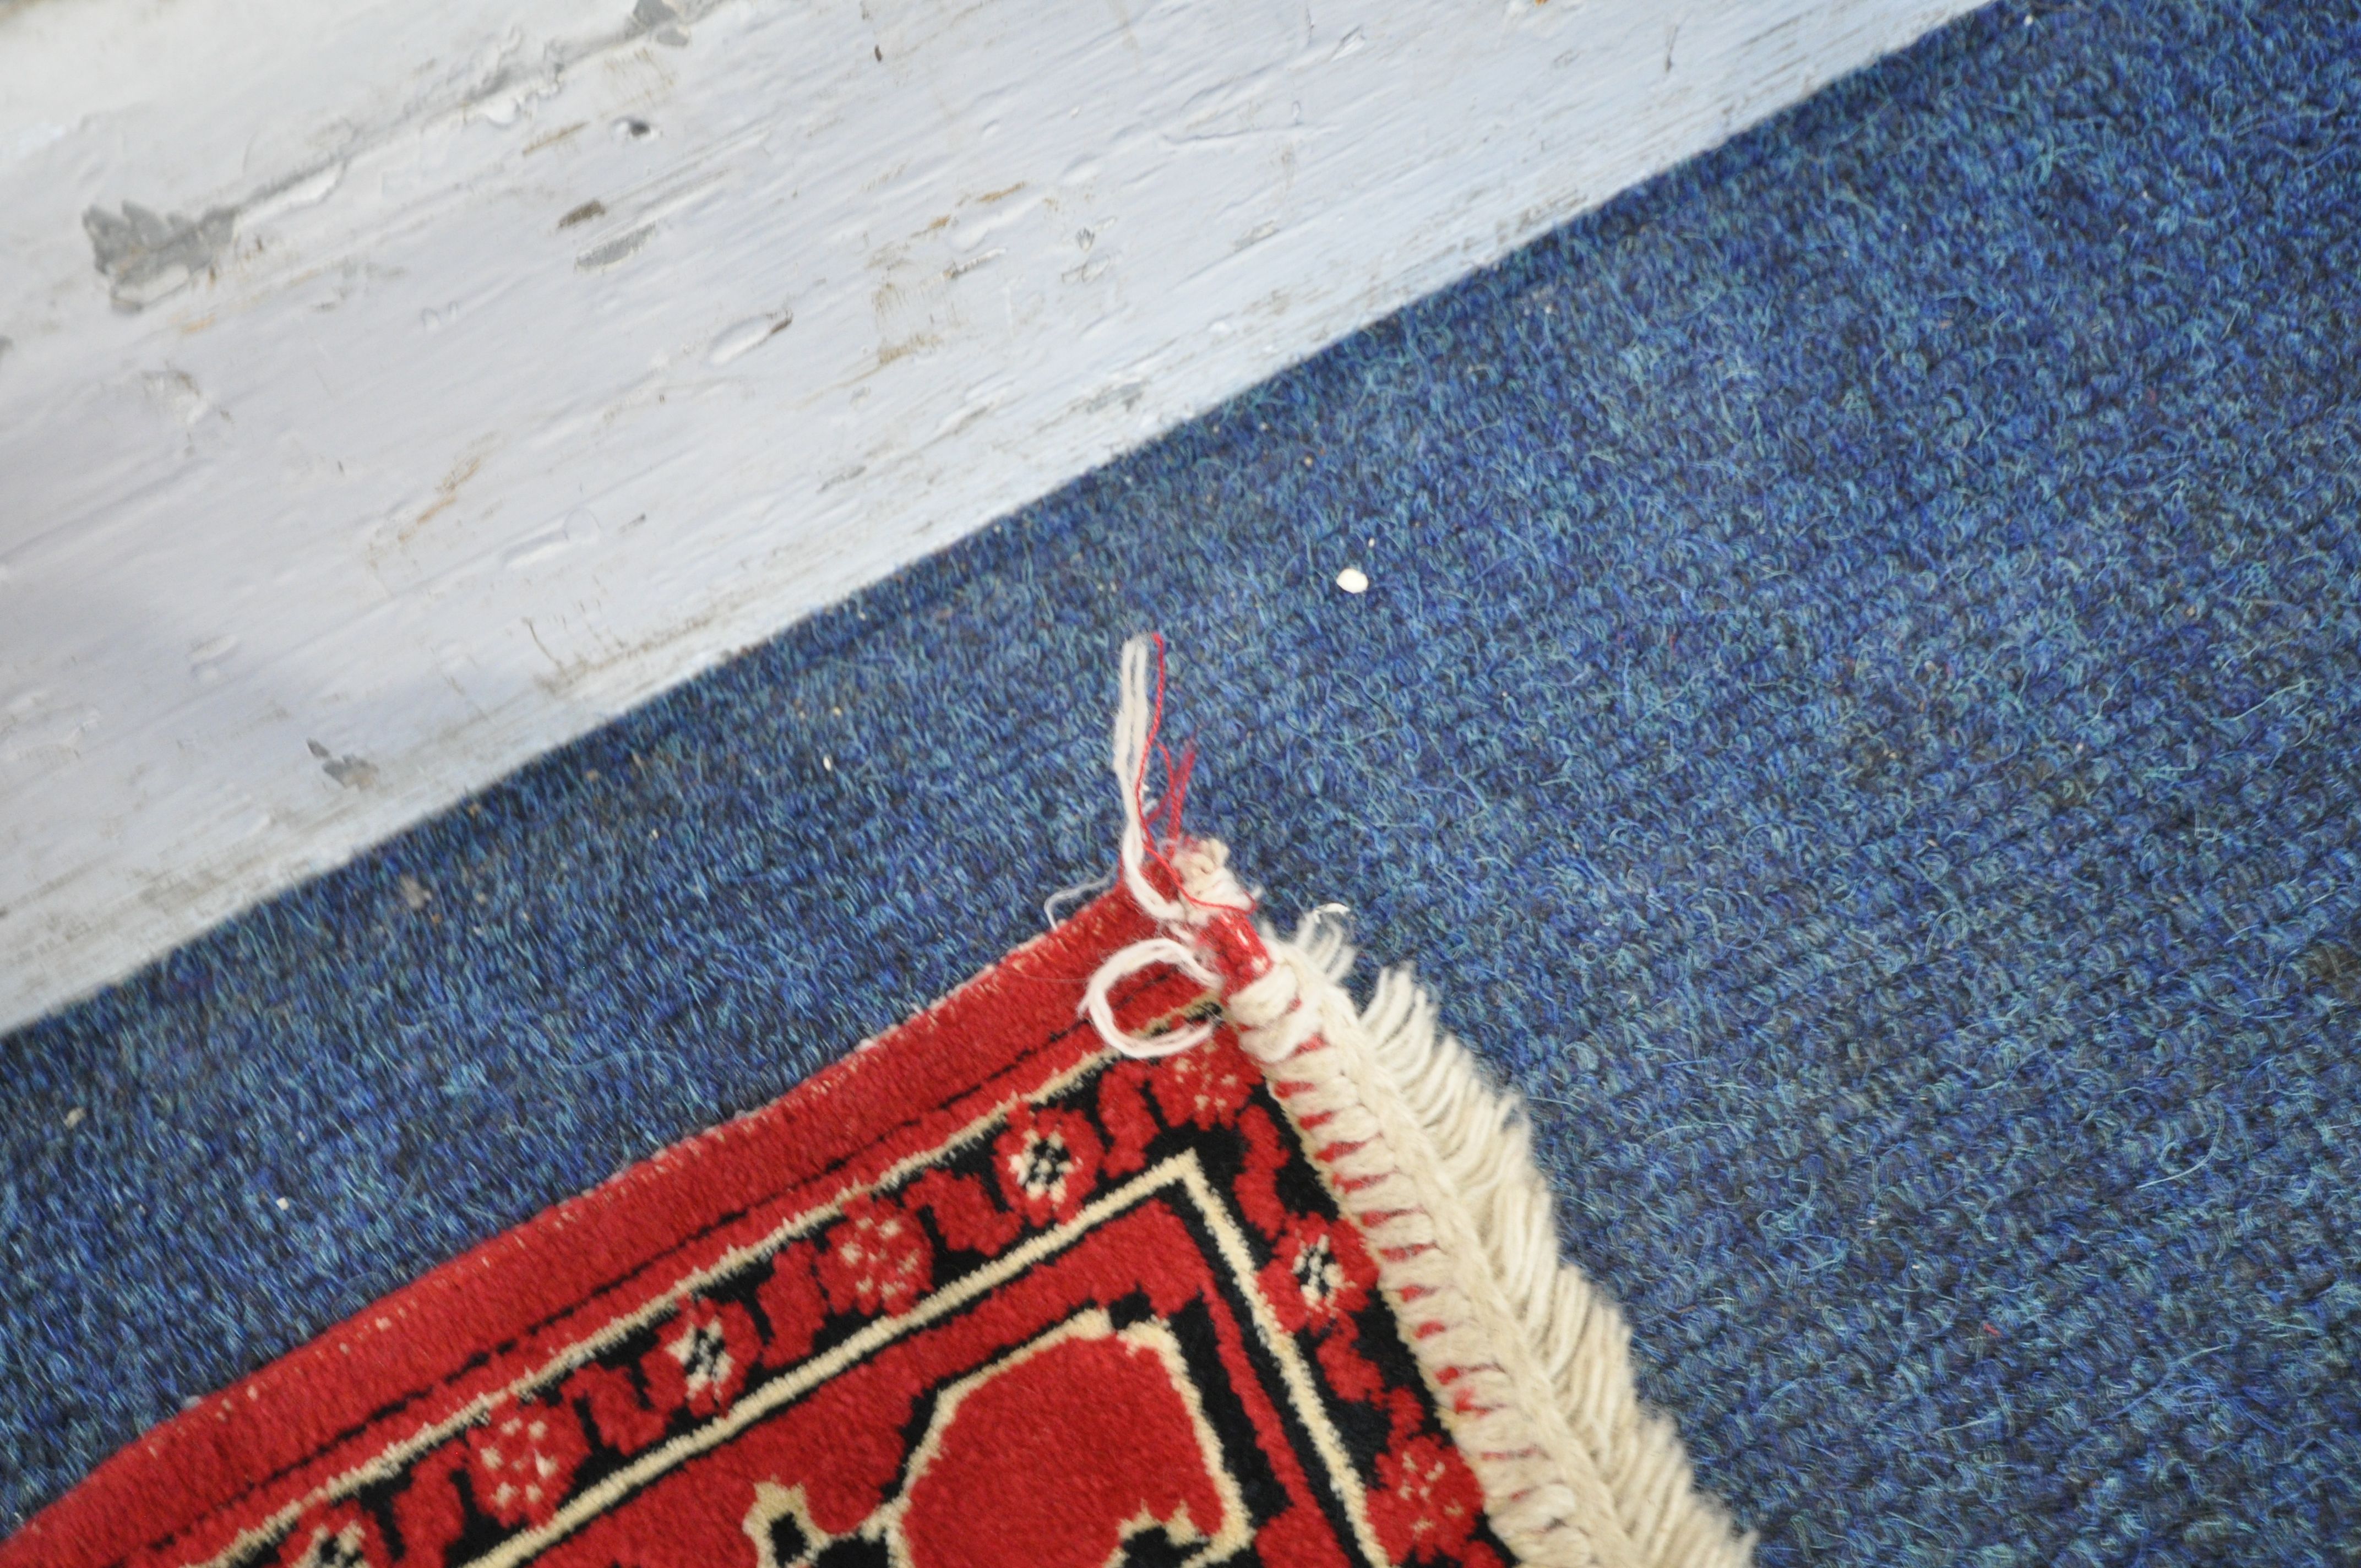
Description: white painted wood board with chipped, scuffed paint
xmin=0 ymin=0 xmax=1969 ymax=1027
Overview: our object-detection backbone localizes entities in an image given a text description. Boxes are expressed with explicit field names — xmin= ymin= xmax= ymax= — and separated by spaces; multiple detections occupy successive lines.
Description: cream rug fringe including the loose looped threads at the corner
xmin=1086 ymin=635 xmax=1754 ymax=1568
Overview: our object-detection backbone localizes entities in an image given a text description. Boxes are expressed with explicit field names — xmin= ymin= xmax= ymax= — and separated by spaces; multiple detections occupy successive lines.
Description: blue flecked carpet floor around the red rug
xmin=0 ymin=0 xmax=2361 ymax=1568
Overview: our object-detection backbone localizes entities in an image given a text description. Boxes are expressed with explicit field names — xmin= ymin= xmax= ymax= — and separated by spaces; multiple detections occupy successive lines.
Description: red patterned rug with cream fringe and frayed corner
xmin=0 ymin=654 xmax=1745 ymax=1568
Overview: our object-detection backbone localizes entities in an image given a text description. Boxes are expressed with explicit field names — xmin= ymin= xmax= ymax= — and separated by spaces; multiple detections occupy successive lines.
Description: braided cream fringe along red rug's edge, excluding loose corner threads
xmin=1242 ymin=914 xmax=1754 ymax=1568
